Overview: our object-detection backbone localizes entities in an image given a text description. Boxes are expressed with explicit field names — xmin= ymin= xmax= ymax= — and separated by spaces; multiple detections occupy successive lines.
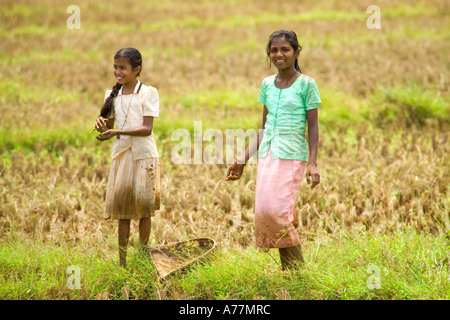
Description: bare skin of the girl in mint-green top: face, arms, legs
xmin=226 ymin=37 xmax=320 ymax=270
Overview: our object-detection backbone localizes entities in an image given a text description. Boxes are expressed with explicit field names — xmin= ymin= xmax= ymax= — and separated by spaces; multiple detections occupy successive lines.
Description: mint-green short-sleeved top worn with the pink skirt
xmin=258 ymin=74 xmax=322 ymax=162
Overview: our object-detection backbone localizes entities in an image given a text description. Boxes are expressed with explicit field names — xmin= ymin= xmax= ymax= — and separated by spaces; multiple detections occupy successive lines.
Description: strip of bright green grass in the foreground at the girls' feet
xmin=0 ymin=230 xmax=450 ymax=300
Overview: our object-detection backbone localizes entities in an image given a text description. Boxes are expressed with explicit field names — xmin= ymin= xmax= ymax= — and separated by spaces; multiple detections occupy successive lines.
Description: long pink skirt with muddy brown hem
xmin=255 ymin=149 xmax=307 ymax=248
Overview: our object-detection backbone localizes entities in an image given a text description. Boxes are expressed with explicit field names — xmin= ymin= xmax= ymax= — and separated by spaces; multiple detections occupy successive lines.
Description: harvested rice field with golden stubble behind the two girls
xmin=0 ymin=0 xmax=450 ymax=299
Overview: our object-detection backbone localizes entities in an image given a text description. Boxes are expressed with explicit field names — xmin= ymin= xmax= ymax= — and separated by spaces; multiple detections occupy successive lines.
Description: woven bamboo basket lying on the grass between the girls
xmin=149 ymin=238 xmax=216 ymax=280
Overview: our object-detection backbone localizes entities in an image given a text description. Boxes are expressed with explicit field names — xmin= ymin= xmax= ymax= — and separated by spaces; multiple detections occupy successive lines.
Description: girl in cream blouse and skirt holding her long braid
xmin=94 ymin=48 xmax=159 ymax=267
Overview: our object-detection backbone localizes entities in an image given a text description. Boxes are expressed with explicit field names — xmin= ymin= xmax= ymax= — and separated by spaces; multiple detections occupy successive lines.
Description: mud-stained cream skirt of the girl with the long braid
xmin=104 ymin=149 xmax=160 ymax=219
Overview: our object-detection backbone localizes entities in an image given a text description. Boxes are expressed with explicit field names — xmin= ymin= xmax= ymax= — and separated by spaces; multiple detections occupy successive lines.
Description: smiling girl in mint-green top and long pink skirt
xmin=226 ymin=30 xmax=321 ymax=270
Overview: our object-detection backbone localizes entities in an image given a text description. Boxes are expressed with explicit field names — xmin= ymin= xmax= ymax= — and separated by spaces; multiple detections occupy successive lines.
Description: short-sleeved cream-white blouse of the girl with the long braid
xmin=105 ymin=81 xmax=159 ymax=160
